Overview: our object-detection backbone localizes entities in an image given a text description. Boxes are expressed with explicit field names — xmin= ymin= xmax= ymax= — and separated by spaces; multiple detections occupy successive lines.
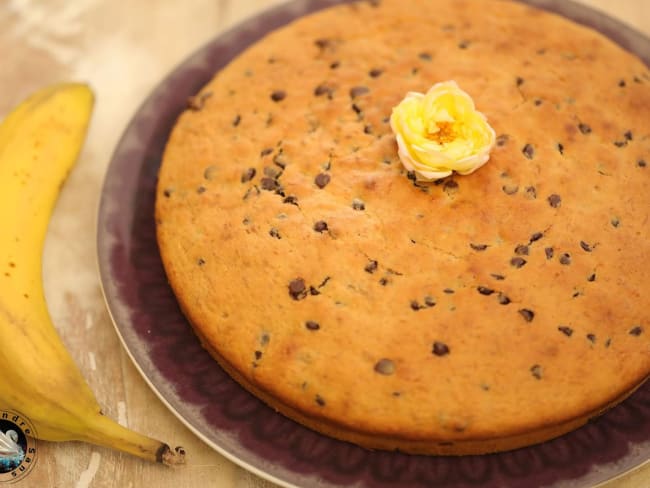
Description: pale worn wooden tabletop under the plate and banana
xmin=0 ymin=0 xmax=650 ymax=488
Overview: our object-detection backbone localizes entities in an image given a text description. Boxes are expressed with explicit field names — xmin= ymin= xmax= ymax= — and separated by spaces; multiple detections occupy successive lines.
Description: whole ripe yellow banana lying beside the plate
xmin=0 ymin=83 xmax=185 ymax=465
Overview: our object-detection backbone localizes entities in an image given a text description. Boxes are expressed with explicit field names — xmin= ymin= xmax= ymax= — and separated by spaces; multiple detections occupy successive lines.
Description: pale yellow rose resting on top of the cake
xmin=390 ymin=81 xmax=495 ymax=180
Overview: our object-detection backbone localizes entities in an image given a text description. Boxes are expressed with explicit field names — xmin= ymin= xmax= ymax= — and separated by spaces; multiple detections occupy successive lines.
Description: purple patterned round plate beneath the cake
xmin=97 ymin=0 xmax=650 ymax=488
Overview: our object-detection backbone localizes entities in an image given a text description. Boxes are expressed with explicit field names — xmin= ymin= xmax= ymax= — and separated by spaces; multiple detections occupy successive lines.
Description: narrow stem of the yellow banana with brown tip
xmin=79 ymin=415 xmax=185 ymax=466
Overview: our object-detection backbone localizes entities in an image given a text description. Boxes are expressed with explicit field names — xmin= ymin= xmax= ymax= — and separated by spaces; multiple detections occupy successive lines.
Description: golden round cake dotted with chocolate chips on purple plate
xmin=156 ymin=0 xmax=650 ymax=454
